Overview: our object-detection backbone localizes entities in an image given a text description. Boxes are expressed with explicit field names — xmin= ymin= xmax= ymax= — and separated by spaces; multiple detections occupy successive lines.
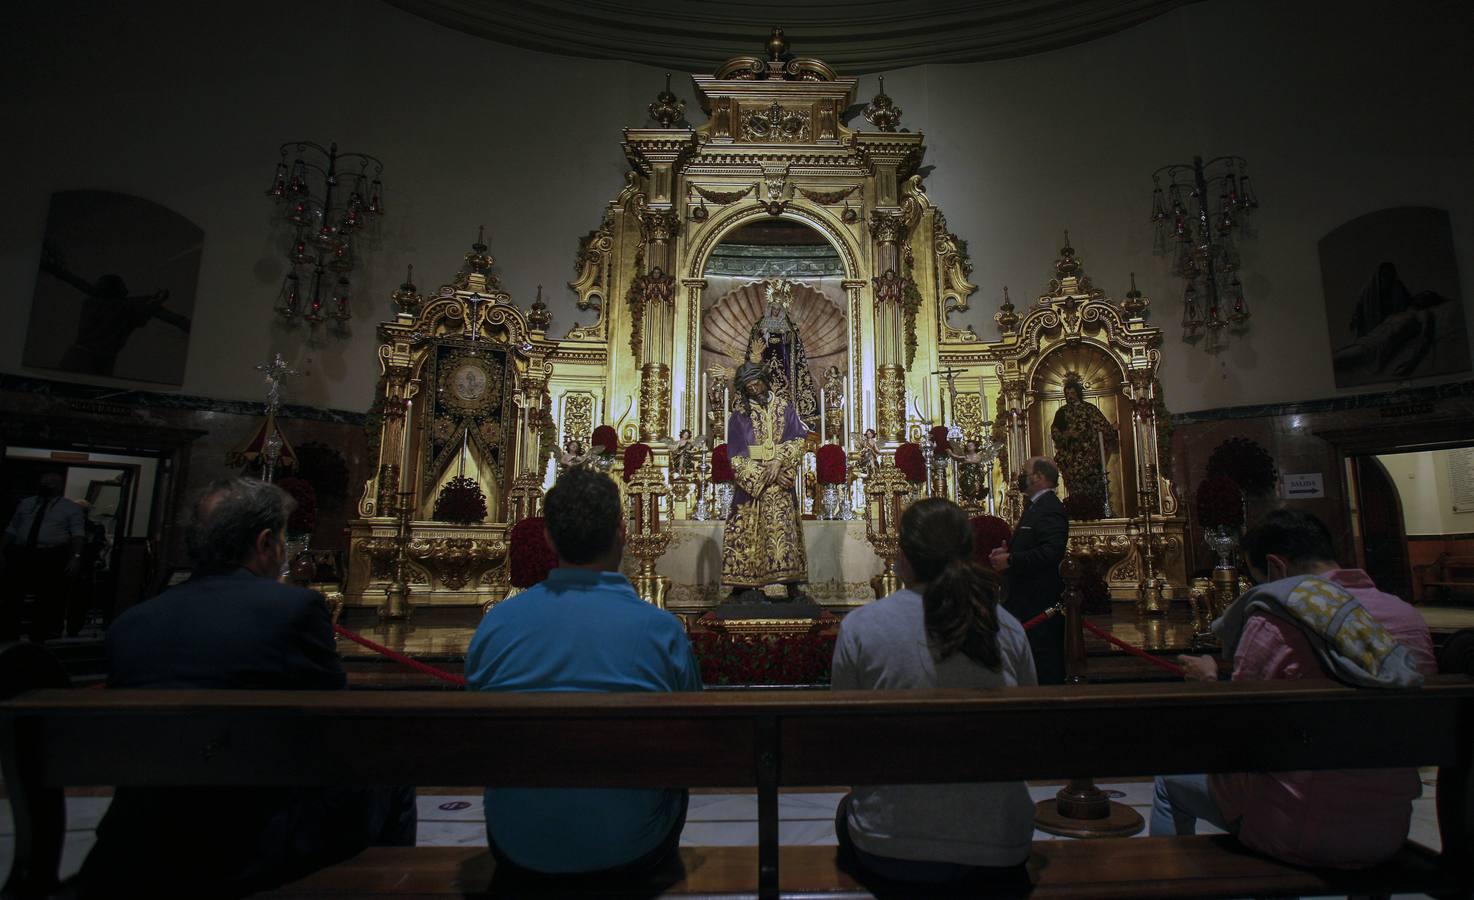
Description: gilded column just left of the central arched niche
xmin=640 ymin=209 xmax=681 ymax=440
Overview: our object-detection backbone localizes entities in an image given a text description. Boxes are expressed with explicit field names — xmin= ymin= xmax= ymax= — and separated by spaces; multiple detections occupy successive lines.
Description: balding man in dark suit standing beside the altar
xmin=989 ymin=457 xmax=1070 ymax=685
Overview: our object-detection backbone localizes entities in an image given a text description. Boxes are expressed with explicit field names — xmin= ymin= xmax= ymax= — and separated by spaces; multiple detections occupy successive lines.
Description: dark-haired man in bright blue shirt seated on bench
xmin=466 ymin=468 xmax=702 ymax=876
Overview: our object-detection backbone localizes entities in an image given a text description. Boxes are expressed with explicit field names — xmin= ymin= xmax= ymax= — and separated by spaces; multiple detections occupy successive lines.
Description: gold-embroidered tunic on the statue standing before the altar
xmin=722 ymin=392 xmax=809 ymax=588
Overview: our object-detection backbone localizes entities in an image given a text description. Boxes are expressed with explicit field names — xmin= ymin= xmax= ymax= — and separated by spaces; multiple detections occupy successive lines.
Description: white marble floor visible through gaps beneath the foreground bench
xmin=0 ymin=770 xmax=1440 ymax=881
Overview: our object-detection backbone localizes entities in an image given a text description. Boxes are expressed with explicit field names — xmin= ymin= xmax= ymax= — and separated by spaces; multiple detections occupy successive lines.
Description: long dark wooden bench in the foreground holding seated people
xmin=0 ymin=645 xmax=1474 ymax=897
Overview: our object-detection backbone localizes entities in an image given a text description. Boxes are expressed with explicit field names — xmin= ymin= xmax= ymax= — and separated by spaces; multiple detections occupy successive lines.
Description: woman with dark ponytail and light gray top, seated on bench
xmin=833 ymin=498 xmax=1038 ymax=887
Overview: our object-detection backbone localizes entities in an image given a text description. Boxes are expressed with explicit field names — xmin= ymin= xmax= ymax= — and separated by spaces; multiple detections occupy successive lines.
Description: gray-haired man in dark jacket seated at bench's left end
xmin=81 ymin=479 xmax=416 ymax=897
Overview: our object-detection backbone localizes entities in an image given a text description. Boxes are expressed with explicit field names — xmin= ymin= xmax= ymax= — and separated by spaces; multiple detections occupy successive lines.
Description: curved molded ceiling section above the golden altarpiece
xmin=388 ymin=0 xmax=1197 ymax=75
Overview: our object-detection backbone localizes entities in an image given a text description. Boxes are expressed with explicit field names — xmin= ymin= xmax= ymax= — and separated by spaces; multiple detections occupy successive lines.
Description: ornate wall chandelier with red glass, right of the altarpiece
xmin=1151 ymin=156 xmax=1259 ymax=354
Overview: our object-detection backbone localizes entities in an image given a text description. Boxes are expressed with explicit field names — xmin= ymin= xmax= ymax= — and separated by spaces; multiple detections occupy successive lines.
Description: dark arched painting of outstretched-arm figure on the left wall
xmin=24 ymin=190 xmax=205 ymax=386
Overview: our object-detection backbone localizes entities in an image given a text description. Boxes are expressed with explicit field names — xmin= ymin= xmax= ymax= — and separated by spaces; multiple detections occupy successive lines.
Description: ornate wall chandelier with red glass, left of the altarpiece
xmin=267 ymin=140 xmax=383 ymax=326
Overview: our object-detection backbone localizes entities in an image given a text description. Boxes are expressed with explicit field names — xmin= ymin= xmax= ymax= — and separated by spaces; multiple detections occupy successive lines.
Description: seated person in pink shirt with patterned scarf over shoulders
xmin=1151 ymin=510 xmax=1437 ymax=868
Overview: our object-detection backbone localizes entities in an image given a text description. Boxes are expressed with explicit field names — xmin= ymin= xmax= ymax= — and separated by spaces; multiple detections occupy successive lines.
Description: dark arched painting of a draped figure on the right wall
xmin=1319 ymin=206 xmax=1470 ymax=387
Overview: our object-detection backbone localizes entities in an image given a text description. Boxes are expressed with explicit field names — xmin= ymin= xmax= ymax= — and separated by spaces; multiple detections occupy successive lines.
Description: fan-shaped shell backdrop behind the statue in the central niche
xmin=702 ymin=281 xmax=849 ymax=382
